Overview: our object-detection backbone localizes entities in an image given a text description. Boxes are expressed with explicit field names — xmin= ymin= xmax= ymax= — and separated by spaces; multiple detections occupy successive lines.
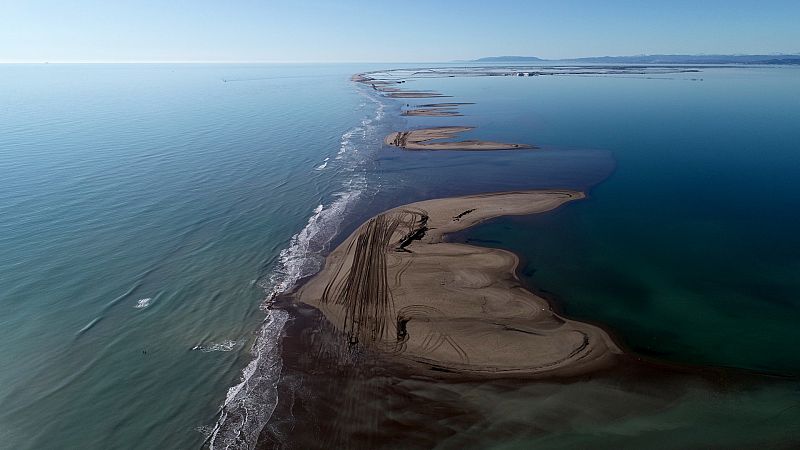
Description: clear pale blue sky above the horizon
xmin=0 ymin=0 xmax=800 ymax=62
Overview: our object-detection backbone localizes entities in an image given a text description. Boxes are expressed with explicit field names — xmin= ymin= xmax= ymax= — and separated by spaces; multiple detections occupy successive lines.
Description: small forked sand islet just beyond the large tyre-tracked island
xmin=383 ymin=127 xmax=534 ymax=151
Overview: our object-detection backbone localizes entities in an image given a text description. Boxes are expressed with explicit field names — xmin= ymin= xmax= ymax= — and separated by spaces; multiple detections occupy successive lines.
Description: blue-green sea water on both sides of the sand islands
xmin=0 ymin=65 xmax=800 ymax=449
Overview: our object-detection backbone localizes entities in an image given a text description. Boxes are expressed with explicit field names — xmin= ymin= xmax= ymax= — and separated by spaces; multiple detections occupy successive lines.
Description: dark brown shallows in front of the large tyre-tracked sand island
xmin=256 ymin=304 xmax=800 ymax=450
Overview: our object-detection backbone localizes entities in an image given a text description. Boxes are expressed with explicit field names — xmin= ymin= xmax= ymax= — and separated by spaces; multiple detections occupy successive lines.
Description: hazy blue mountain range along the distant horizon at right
xmin=468 ymin=54 xmax=800 ymax=64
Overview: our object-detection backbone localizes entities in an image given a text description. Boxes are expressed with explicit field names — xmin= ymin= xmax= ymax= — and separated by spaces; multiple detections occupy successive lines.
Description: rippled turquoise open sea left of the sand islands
xmin=0 ymin=65 xmax=388 ymax=449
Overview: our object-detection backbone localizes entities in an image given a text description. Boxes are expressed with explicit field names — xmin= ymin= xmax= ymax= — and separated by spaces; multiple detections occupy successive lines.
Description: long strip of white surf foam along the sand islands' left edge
xmin=209 ymin=85 xmax=384 ymax=449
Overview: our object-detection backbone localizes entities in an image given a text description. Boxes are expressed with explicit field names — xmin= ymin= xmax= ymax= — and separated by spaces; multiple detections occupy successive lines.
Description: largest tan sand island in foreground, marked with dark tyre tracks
xmin=295 ymin=190 xmax=621 ymax=377
